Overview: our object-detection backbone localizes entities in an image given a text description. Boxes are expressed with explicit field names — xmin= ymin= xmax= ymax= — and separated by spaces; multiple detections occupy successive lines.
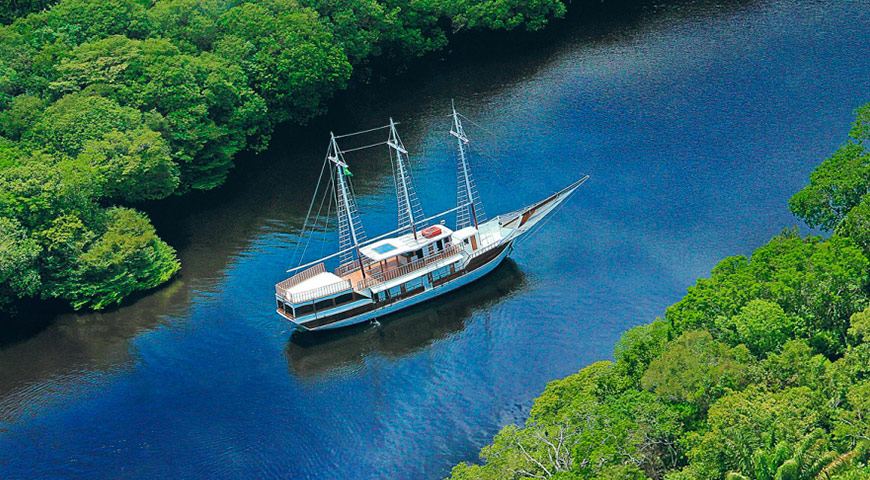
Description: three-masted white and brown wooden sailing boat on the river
xmin=275 ymin=108 xmax=589 ymax=331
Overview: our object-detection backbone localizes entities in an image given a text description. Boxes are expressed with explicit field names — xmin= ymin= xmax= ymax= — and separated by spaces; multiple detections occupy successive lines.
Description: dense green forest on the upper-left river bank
xmin=0 ymin=0 xmax=566 ymax=311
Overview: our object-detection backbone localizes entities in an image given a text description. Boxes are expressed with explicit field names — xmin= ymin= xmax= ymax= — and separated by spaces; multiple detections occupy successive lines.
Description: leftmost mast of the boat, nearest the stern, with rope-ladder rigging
xmin=327 ymin=132 xmax=366 ymax=278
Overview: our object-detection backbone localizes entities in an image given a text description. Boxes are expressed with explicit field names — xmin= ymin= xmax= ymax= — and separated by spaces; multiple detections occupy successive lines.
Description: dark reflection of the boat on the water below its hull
xmin=285 ymin=258 xmax=527 ymax=379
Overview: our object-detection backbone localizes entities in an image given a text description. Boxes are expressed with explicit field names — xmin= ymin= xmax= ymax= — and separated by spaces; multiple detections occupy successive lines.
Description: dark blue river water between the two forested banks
xmin=0 ymin=1 xmax=870 ymax=479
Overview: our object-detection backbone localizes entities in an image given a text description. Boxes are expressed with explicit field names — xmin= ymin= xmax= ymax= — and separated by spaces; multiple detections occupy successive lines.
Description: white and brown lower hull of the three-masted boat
xmin=294 ymin=241 xmax=513 ymax=332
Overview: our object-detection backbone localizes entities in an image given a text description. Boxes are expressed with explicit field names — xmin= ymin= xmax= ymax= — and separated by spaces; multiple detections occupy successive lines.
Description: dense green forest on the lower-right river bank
xmin=451 ymin=104 xmax=870 ymax=480
